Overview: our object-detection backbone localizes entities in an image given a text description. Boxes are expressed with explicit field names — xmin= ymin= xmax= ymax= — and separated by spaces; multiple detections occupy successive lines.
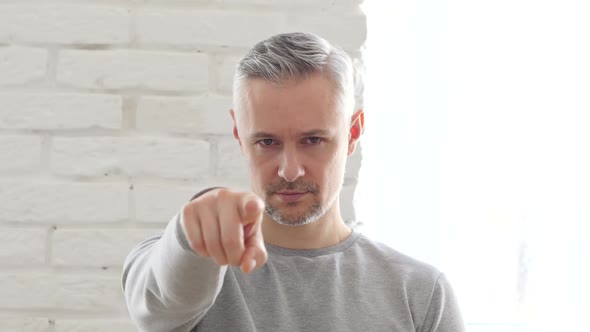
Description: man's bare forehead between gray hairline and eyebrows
xmin=239 ymin=75 xmax=344 ymax=134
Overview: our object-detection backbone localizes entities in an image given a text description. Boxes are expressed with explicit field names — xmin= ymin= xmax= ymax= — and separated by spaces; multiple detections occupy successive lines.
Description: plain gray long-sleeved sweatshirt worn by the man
xmin=123 ymin=214 xmax=464 ymax=332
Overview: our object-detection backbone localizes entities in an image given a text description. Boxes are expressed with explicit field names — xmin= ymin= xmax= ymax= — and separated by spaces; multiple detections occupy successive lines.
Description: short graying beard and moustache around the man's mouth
xmin=264 ymin=179 xmax=327 ymax=226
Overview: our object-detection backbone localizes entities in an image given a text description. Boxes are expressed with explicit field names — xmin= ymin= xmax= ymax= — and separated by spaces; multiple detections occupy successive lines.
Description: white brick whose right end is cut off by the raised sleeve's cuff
xmin=52 ymin=228 xmax=162 ymax=267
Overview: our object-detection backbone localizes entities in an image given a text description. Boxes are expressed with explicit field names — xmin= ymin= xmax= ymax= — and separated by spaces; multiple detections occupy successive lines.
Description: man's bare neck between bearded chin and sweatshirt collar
xmin=262 ymin=204 xmax=351 ymax=249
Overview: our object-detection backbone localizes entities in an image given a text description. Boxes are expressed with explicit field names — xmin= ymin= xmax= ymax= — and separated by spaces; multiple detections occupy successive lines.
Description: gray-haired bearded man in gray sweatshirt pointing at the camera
xmin=123 ymin=33 xmax=463 ymax=332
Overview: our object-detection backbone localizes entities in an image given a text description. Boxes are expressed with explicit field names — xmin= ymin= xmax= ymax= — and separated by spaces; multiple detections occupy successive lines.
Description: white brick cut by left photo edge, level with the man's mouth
xmin=0 ymin=180 xmax=129 ymax=224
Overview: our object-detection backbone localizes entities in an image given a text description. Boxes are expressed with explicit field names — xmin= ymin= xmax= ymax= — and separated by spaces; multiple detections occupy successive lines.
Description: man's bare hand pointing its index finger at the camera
xmin=182 ymin=188 xmax=268 ymax=273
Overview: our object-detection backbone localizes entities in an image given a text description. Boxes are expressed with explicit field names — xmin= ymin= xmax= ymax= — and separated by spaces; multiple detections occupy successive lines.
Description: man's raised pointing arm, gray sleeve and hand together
xmin=123 ymin=188 xmax=267 ymax=332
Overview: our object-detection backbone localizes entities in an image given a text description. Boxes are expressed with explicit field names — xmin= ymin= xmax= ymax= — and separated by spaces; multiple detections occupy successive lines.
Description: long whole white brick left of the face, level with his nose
xmin=51 ymin=137 xmax=209 ymax=179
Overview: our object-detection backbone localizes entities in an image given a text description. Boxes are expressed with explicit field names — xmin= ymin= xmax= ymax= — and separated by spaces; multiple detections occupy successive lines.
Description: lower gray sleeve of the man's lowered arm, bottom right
xmin=419 ymin=274 xmax=465 ymax=332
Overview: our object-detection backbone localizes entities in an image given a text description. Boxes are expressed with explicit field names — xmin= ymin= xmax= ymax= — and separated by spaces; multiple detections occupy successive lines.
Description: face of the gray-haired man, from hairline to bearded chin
xmin=232 ymin=75 xmax=356 ymax=225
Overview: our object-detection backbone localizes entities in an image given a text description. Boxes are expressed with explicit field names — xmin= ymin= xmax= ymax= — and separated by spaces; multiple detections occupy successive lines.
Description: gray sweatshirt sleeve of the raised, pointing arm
xmin=122 ymin=211 xmax=227 ymax=332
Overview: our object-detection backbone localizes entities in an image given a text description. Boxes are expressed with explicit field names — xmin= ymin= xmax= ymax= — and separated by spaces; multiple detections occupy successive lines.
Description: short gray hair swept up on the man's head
xmin=233 ymin=32 xmax=354 ymax=123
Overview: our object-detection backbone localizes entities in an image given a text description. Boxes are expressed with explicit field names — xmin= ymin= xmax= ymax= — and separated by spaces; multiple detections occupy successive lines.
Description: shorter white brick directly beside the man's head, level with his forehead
xmin=136 ymin=96 xmax=232 ymax=134
